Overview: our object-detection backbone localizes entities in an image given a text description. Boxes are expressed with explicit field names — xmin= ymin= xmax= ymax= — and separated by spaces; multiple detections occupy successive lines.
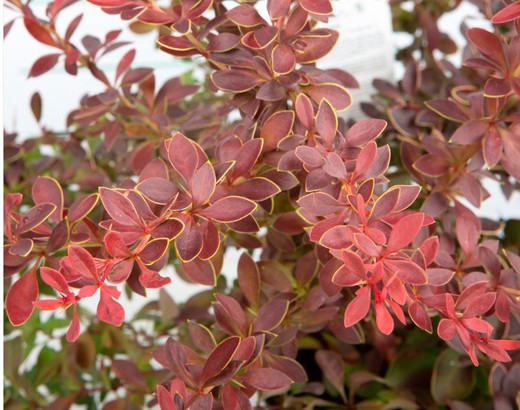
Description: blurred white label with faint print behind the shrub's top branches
xmin=318 ymin=0 xmax=394 ymax=118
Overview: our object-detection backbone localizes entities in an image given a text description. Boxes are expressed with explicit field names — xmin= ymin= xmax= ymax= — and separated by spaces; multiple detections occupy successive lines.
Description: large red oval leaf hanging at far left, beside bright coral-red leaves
xmin=5 ymin=270 xmax=38 ymax=326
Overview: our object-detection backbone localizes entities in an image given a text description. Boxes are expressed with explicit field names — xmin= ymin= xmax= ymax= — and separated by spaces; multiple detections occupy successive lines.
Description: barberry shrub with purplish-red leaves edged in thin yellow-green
xmin=4 ymin=0 xmax=520 ymax=410
